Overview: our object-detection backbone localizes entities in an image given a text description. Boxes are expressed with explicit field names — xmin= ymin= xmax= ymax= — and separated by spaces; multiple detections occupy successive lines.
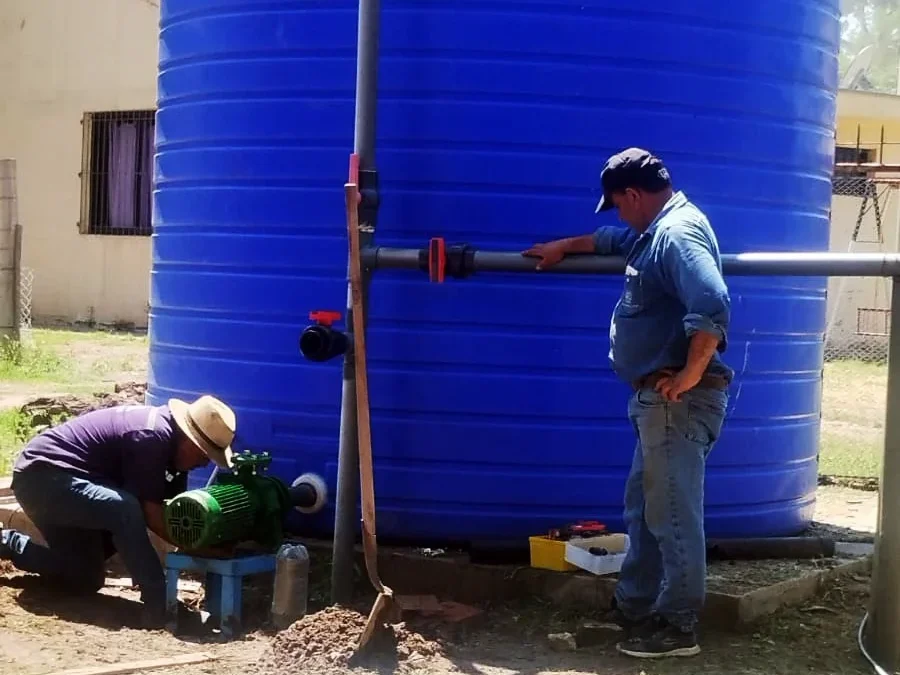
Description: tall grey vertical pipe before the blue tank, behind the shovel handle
xmin=331 ymin=0 xmax=380 ymax=604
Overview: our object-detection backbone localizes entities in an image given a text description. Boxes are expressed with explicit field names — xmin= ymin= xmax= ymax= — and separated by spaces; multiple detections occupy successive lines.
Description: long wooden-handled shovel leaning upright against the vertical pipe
xmin=344 ymin=183 xmax=397 ymax=650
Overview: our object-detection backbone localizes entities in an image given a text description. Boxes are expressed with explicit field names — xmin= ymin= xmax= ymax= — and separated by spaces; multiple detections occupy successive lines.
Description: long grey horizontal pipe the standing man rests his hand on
xmin=362 ymin=246 xmax=900 ymax=277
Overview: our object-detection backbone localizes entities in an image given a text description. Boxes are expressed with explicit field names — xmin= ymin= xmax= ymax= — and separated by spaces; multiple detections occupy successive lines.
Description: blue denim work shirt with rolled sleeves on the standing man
xmin=594 ymin=192 xmax=734 ymax=382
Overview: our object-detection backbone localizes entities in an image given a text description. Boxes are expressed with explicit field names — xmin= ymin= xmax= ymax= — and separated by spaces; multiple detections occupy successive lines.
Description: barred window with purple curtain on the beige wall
xmin=79 ymin=110 xmax=156 ymax=236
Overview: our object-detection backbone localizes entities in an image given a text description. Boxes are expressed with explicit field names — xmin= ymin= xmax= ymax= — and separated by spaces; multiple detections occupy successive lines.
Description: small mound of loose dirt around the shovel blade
xmin=259 ymin=607 xmax=442 ymax=675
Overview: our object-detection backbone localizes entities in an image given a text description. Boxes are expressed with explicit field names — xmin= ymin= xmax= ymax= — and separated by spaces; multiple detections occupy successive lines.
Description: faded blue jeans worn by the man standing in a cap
xmin=616 ymin=388 xmax=728 ymax=630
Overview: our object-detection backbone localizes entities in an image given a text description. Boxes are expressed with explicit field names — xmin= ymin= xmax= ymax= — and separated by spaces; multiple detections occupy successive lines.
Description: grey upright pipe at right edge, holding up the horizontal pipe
xmin=869 ymin=277 xmax=900 ymax=673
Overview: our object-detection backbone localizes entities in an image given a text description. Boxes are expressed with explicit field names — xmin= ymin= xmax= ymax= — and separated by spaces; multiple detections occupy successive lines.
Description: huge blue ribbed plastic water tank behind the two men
xmin=150 ymin=0 xmax=839 ymax=541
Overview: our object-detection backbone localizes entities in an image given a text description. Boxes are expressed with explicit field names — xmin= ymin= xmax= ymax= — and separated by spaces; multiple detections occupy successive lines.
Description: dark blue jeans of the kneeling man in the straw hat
xmin=2 ymin=465 xmax=165 ymax=609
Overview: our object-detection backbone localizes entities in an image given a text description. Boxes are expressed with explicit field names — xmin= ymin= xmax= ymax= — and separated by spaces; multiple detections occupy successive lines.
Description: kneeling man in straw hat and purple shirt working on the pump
xmin=0 ymin=396 xmax=236 ymax=628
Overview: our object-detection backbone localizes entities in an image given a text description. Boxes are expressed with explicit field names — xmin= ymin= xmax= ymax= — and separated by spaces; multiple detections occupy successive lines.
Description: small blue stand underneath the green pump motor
xmin=166 ymin=553 xmax=275 ymax=640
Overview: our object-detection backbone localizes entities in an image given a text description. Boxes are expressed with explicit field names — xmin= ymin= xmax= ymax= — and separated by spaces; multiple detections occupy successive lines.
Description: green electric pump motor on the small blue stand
xmin=165 ymin=451 xmax=326 ymax=551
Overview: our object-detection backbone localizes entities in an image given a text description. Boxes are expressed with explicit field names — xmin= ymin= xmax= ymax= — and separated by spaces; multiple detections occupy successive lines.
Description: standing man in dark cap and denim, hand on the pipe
xmin=524 ymin=148 xmax=734 ymax=658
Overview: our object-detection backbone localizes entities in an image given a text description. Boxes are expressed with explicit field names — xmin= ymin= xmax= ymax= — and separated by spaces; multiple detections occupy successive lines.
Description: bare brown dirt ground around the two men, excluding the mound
xmin=0 ymin=486 xmax=877 ymax=675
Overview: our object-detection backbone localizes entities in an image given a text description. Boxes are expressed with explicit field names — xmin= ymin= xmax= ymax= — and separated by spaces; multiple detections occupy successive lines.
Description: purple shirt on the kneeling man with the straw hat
xmin=13 ymin=405 xmax=175 ymax=503
